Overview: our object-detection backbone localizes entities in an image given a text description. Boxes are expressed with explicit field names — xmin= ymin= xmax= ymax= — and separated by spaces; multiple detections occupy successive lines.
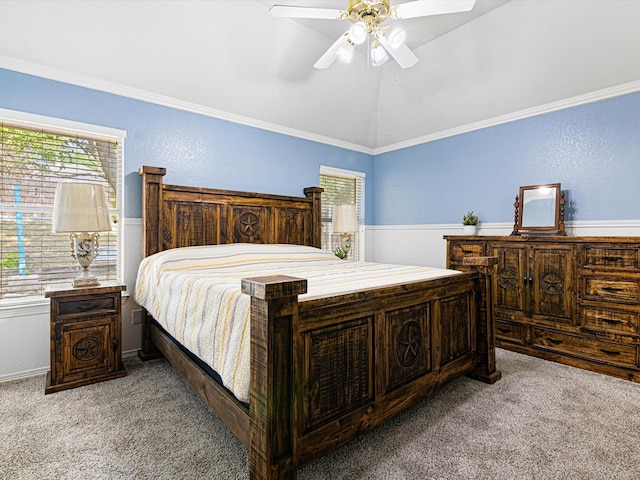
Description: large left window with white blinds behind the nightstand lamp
xmin=0 ymin=111 xmax=124 ymax=303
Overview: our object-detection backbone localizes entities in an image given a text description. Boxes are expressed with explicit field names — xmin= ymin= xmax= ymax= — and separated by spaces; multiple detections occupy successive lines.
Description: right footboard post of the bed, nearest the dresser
xmin=464 ymin=257 xmax=502 ymax=383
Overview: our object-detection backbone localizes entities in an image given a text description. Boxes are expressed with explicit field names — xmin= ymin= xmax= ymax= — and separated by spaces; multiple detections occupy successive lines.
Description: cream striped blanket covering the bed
xmin=135 ymin=244 xmax=460 ymax=402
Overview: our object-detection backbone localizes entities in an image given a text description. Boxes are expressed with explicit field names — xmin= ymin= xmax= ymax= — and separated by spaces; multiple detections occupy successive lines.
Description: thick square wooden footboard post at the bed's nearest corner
xmin=242 ymin=275 xmax=307 ymax=480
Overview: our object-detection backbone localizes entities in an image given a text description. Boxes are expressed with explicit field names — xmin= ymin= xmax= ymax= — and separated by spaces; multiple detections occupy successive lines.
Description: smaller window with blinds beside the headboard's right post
xmin=320 ymin=167 xmax=365 ymax=260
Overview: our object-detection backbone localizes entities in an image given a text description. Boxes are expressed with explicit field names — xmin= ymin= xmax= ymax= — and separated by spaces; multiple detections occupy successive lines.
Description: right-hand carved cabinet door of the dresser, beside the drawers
xmin=527 ymin=245 xmax=575 ymax=324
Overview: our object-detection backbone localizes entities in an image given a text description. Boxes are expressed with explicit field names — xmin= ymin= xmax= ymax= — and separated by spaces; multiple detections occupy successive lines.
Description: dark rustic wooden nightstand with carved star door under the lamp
xmin=44 ymin=282 xmax=127 ymax=394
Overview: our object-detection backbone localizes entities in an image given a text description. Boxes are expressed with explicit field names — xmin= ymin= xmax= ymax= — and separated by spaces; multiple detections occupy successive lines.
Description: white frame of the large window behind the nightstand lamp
xmin=0 ymin=108 xmax=127 ymax=312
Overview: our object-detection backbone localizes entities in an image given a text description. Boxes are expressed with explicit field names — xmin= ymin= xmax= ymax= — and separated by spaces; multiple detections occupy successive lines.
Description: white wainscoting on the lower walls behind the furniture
xmin=5 ymin=218 xmax=640 ymax=382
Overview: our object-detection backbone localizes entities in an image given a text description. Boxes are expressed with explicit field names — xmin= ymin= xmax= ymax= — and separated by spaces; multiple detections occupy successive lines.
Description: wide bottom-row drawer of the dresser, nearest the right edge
xmin=533 ymin=328 xmax=638 ymax=366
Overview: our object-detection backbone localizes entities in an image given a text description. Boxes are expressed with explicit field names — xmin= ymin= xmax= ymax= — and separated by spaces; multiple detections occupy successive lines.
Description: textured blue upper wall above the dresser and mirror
xmin=373 ymin=93 xmax=640 ymax=225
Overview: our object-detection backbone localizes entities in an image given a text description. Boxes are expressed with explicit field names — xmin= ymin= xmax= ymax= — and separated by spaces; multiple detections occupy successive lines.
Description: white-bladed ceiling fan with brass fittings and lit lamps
xmin=269 ymin=0 xmax=476 ymax=69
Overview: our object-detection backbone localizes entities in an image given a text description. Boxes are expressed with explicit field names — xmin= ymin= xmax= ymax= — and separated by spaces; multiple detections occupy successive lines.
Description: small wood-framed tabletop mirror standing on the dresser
xmin=511 ymin=183 xmax=566 ymax=235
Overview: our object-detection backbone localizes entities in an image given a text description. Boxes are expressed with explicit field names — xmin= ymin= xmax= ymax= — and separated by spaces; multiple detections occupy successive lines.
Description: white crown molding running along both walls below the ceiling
xmin=0 ymin=55 xmax=640 ymax=156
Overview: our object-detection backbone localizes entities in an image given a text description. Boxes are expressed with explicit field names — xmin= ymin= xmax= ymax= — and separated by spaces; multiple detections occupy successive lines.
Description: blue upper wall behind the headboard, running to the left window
xmin=0 ymin=69 xmax=373 ymax=224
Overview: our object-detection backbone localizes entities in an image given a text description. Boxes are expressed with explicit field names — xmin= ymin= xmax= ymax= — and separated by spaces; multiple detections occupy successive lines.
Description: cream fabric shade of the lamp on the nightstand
xmin=52 ymin=183 xmax=111 ymax=233
